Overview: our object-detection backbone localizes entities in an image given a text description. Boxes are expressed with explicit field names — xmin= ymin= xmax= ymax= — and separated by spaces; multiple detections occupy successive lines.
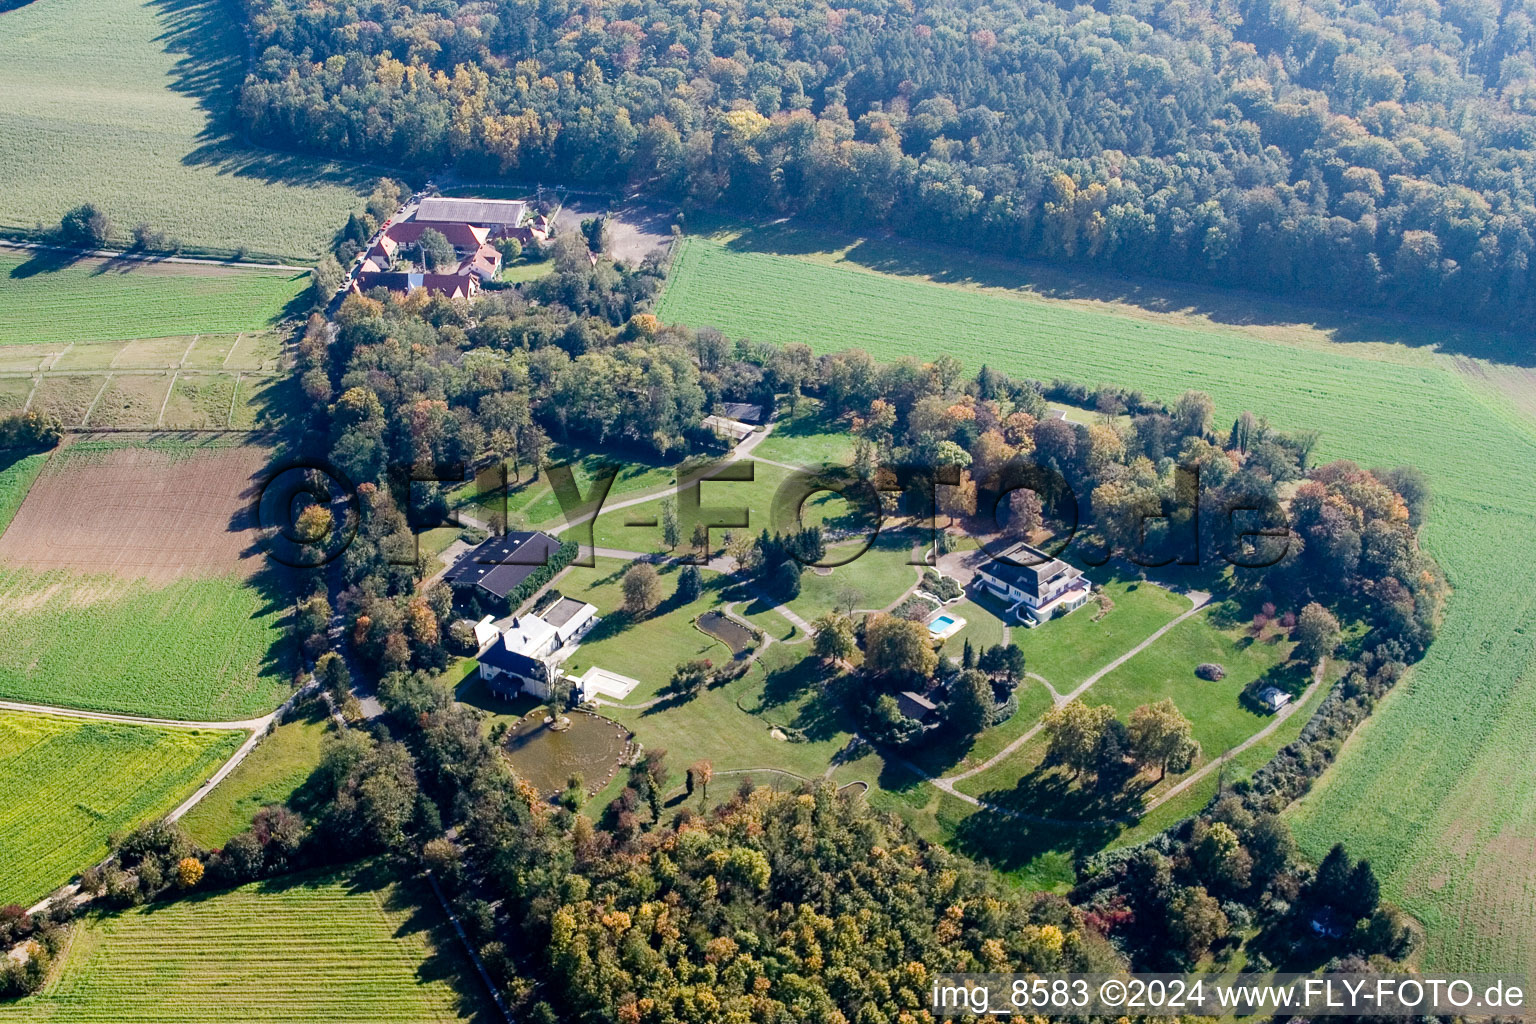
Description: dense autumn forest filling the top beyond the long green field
xmin=240 ymin=0 xmax=1536 ymax=325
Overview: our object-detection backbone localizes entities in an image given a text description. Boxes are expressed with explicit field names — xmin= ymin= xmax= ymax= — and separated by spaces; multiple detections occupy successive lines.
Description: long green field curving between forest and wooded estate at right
xmin=659 ymin=222 xmax=1536 ymax=970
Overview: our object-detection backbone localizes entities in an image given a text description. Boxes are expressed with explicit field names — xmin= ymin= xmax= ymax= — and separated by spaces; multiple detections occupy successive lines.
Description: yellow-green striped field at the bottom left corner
xmin=0 ymin=866 xmax=488 ymax=1024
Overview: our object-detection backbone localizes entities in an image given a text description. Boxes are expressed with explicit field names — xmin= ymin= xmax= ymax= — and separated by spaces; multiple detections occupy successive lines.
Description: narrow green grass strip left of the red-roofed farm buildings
xmin=0 ymin=253 xmax=309 ymax=346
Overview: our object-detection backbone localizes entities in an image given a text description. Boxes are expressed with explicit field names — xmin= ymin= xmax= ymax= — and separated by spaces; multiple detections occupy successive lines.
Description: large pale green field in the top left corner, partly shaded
xmin=0 ymin=0 xmax=368 ymax=262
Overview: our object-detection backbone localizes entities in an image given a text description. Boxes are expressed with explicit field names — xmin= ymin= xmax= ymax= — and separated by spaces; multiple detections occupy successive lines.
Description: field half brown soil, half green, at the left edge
xmin=0 ymin=438 xmax=293 ymax=722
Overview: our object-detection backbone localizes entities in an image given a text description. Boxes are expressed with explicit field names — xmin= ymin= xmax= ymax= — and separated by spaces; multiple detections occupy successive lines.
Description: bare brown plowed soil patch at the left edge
xmin=0 ymin=441 xmax=270 ymax=582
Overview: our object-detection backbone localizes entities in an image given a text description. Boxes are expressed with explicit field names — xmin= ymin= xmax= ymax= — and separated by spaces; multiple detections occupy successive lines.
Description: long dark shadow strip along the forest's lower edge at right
xmin=728 ymin=221 xmax=1536 ymax=367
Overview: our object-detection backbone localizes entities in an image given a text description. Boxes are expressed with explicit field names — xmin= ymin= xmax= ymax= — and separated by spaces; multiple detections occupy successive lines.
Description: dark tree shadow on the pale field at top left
xmin=146 ymin=0 xmax=379 ymax=192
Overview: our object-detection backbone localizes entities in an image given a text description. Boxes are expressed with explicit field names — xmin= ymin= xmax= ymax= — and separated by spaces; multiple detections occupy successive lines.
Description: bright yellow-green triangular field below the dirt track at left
xmin=0 ymin=712 xmax=246 ymax=906
